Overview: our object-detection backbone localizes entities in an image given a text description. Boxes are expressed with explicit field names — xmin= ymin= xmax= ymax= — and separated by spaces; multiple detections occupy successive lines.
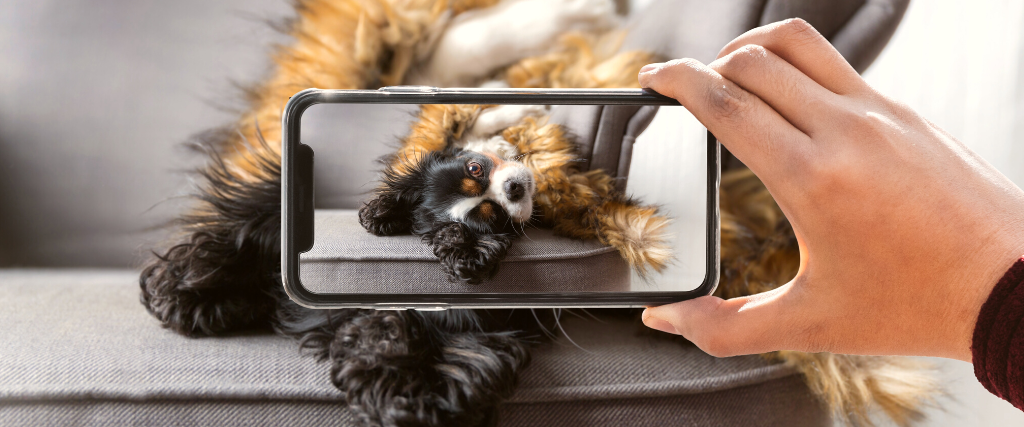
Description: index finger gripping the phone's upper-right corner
xmin=639 ymin=58 xmax=811 ymax=178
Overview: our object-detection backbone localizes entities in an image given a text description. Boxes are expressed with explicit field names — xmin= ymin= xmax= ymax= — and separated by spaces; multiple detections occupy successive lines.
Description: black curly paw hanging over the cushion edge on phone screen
xmin=423 ymin=222 xmax=512 ymax=285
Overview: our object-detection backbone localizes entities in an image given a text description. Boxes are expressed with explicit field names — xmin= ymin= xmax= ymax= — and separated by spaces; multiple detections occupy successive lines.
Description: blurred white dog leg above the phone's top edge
xmin=410 ymin=0 xmax=618 ymax=86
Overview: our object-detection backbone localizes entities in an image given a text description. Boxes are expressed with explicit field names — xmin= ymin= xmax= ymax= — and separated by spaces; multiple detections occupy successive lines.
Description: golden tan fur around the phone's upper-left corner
xmin=223 ymin=0 xmax=498 ymax=176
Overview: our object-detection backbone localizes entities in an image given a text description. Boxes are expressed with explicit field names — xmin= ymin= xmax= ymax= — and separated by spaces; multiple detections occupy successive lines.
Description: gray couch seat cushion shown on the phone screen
xmin=299 ymin=210 xmax=630 ymax=294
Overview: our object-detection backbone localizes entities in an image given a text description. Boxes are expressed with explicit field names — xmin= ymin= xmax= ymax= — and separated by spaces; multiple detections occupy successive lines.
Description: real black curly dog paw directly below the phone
xmin=329 ymin=310 xmax=528 ymax=426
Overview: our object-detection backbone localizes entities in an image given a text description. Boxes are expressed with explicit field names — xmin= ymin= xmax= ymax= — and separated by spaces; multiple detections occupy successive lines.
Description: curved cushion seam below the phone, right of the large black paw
xmin=507 ymin=364 xmax=799 ymax=403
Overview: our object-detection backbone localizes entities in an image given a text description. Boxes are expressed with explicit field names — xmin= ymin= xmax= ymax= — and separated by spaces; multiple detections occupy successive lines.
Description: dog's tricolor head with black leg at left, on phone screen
xmin=360 ymin=147 xmax=537 ymax=234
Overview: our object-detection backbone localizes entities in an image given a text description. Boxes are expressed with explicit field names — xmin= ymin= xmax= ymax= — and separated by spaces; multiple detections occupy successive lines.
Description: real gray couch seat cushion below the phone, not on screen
xmin=0 ymin=270 xmax=829 ymax=426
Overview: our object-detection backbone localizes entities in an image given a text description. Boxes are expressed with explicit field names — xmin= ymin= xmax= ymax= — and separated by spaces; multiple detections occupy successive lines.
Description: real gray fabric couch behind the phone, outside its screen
xmin=0 ymin=0 xmax=906 ymax=426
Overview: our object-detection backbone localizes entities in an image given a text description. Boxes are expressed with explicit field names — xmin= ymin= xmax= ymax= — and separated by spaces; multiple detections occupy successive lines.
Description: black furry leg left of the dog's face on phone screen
xmin=359 ymin=156 xmax=432 ymax=236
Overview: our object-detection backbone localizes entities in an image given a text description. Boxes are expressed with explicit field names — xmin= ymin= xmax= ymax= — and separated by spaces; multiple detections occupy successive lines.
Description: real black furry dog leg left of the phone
xmin=139 ymin=135 xmax=281 ymax=336
